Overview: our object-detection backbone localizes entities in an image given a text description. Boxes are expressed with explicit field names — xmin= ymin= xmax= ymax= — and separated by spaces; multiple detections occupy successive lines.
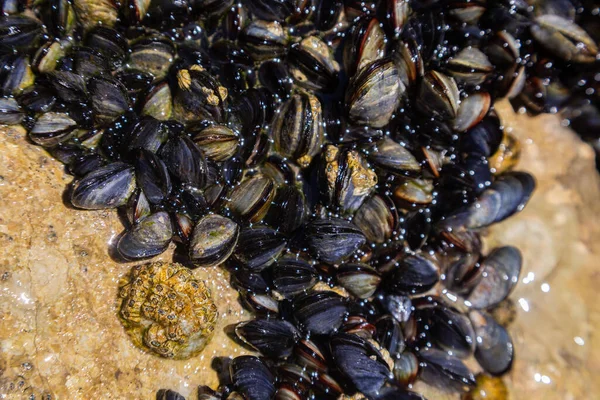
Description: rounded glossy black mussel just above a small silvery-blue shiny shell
xmin=385 ymin=254 xmax=440 ymax=294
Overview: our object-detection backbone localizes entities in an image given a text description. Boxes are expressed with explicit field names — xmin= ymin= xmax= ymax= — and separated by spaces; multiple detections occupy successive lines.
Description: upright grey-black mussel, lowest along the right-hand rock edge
xmin=469 ymin=311 xmax=514 ymax=375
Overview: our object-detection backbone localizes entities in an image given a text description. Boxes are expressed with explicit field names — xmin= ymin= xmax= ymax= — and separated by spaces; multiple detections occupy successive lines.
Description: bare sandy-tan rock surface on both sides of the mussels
xmin=0 ymin=98 xmax=600 ymax=400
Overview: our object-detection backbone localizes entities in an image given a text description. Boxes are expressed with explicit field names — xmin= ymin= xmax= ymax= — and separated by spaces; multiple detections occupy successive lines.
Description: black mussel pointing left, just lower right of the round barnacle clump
xmin=235 ymin=319 xmax=300 ymax=358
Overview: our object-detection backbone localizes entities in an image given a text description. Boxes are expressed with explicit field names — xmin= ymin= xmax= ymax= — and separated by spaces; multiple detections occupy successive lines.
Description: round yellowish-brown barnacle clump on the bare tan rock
xmin=119 ymin=262 xmax=218 ymax=359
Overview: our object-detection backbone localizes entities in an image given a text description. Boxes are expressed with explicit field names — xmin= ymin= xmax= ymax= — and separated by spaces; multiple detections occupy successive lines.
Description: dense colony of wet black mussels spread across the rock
xmin=0 ymin=0 xmax=600 ymax=400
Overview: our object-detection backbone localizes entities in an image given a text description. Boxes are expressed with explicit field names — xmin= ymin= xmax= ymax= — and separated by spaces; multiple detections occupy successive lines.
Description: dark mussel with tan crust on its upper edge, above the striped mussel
xmin=287 ymin=36 xmax=339 ymax=92
